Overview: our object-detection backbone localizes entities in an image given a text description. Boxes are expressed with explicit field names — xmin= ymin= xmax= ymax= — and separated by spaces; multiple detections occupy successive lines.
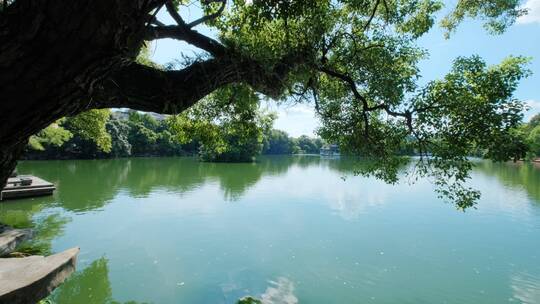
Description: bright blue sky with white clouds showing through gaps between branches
xmin=151 ymin=0 xmax=540 ymax=137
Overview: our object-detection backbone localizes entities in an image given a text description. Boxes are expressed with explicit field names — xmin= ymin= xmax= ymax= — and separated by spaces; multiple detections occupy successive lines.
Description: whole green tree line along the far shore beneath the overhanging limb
xmin=24 ymin=109 xmax=323 ymax=161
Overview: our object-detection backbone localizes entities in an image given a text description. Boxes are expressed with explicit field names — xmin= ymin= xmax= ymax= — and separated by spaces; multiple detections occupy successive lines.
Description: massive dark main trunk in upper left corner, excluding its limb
xmin=0 ymin=0 xmax=153 ymax=185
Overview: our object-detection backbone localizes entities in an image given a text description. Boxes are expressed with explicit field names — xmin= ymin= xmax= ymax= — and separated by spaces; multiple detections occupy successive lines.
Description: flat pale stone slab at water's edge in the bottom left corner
xmin=0 ymin=248 xmax=79 ymax=304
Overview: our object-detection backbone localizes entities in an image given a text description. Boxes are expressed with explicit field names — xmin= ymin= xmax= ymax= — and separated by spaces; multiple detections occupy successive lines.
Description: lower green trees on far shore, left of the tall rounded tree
xmin=27 ymin=110 xmax=192 ymax=158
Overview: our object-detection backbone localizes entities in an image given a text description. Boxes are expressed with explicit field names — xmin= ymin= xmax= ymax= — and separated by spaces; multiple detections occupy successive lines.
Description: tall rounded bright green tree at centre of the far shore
xmin=173 ymin=86 xmax=274 ymax=162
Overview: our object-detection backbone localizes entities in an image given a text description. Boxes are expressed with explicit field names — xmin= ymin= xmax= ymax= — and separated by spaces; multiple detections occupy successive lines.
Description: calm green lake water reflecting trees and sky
xmin=0 ymin=156 xmax=540 ymax=304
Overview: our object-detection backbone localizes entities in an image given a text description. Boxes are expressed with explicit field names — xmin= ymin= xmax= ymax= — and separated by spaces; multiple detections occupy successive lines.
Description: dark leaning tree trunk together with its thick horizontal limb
xmin=0 ymin=0 xmax=300 ymax=186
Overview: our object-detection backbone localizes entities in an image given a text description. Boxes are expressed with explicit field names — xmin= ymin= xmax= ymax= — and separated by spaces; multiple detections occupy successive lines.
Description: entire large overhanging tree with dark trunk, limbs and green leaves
xmin=0 ymin=0 xmax=527 ymax=207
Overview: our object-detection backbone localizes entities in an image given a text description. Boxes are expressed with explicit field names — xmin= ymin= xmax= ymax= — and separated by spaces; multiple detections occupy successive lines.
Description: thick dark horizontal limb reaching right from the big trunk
xmin=92 ymin=55 xmax=305 ymax=113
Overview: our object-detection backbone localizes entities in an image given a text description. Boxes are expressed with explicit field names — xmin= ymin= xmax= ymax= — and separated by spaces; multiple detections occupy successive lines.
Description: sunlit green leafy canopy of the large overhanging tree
xmin=158 ymin=0 xmax=529 ymax=209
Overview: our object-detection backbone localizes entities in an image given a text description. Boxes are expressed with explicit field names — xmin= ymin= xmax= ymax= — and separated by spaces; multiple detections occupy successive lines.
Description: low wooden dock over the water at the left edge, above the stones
xmin=0 ymin=175 xmax=56 ymax=200
